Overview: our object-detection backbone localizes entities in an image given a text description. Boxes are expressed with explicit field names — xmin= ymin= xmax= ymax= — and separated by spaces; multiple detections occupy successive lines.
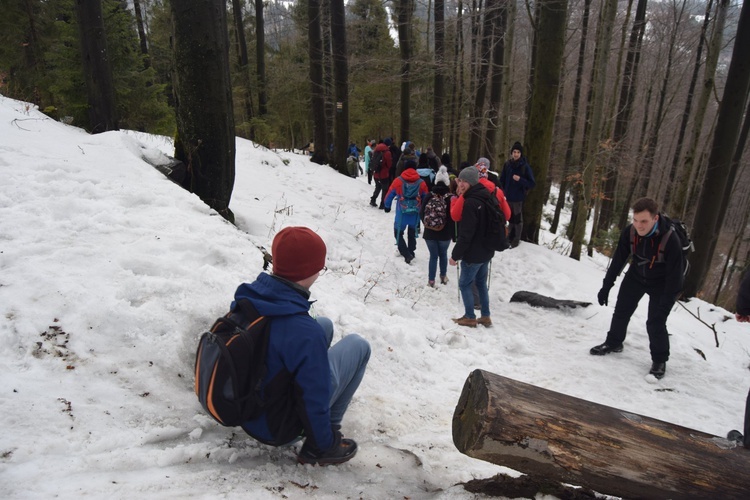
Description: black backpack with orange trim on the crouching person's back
xmin=195 ymin=299 xmax=271 ymax=427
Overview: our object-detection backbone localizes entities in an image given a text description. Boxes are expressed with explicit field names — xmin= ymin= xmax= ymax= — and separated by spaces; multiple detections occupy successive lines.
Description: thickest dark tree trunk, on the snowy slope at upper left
xmin=170 ymin=0 xmax=235 ymax=222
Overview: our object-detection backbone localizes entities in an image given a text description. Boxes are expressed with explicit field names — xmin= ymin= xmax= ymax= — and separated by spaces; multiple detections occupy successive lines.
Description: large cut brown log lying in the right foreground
xmin=453 ymin=370 xmax=750 ymax=500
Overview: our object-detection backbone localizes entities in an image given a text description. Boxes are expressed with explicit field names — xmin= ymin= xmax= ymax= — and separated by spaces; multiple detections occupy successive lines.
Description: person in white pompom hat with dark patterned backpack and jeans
xmin=420 ymin=166 xmax=456 ymax=287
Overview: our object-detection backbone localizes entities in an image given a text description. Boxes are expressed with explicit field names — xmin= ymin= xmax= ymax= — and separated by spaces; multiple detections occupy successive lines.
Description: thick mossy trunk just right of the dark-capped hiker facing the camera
xmin=523 ymin=0 xmax=568 ymax=243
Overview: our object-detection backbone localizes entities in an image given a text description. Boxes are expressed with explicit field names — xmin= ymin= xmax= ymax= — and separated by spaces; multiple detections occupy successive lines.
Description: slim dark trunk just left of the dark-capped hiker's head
xmin=482 ymin=0 xmax=508 ymax=161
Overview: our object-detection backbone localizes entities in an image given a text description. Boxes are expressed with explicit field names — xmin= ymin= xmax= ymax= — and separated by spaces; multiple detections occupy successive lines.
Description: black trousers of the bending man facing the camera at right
xmin=606 ymin=272 xmax=674 ymax=363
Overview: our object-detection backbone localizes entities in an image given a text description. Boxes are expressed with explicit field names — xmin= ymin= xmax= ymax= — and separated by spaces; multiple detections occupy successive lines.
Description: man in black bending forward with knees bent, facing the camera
xmin=590 ymin=198 xmax=685 ymax=378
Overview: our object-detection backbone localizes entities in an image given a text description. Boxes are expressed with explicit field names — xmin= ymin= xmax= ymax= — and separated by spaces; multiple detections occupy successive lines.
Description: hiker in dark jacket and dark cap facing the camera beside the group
xmin=498 ymin=142 xmax=536 ymax=248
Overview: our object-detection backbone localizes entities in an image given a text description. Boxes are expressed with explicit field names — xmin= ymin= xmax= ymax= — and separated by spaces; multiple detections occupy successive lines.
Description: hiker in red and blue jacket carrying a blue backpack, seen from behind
xmin=385 ymin=168 xmax=427 ymax=264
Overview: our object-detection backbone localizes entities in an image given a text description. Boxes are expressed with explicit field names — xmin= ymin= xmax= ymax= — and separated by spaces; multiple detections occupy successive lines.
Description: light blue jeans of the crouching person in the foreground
xmin=317 ymin=317 xmax=370 ymax=425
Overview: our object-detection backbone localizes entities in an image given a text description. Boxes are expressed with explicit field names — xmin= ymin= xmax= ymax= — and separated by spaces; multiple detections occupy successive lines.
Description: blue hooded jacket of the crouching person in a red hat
xmin=232 ymin=273 xmax=334 ymax=451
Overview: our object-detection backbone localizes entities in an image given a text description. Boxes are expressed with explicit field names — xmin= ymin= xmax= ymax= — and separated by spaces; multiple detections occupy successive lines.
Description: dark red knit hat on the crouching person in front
xmin=271 ymin=226 xmax=326 ymax=281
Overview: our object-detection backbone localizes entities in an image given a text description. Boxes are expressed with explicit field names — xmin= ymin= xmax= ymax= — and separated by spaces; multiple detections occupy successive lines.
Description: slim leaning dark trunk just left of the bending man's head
xmin=597 ymin=0 xmax=648 ymax=234
